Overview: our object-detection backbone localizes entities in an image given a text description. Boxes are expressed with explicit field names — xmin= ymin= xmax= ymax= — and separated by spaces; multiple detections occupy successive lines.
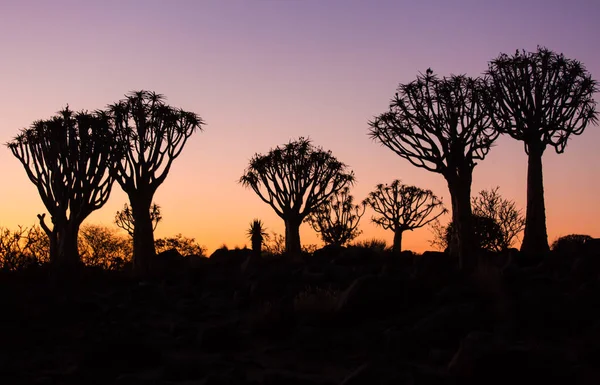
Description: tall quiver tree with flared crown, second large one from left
xmin=108 ymin=91 xmax=204 ymax=275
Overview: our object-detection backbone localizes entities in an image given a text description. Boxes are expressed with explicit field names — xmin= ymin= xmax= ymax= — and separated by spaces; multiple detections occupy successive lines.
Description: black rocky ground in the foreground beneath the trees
xmin=0 ymin=249 xmax=600 ymax=385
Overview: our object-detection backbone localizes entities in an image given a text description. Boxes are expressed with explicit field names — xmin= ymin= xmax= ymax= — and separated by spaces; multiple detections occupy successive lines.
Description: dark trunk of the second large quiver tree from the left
xmin=129 ymin=195 xmax=156 ymax=276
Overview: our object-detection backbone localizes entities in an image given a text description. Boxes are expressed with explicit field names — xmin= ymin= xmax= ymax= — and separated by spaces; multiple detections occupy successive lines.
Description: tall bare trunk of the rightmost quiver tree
xmin=521 ymin=141 xmax=550 ymax=255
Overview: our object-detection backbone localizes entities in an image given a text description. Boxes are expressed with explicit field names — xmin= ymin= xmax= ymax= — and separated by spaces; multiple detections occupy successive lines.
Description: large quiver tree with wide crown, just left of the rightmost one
xmin=369 ymin=69 xmax=498 ymax=269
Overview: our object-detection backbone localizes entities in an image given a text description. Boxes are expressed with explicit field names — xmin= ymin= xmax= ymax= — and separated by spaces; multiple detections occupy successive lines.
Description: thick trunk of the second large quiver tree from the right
xmin=446 ymin=171 xmax=477 ymax=271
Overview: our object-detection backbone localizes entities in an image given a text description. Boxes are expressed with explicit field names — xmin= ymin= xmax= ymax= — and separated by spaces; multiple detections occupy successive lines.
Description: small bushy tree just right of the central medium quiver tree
xmin=306 ymin=186 xmax=365 ymax=246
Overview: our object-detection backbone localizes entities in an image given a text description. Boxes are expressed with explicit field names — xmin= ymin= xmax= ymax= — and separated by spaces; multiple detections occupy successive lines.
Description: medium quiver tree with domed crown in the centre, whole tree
xmin=240 ymin=137 xmax=354 ymax=255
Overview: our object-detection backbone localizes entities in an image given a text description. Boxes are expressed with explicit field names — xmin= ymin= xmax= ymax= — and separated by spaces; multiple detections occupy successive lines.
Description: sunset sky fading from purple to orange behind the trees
xmin=0 ymin=0 xmax=600 ymax=252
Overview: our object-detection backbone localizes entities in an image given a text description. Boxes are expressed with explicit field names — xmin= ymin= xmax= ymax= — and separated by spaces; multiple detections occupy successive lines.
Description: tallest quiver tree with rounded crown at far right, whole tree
xmin=487 ymin=47 xmax=598 ymax=254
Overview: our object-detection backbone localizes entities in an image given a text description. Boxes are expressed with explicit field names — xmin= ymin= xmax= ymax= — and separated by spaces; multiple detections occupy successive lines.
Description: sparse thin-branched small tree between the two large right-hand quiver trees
xmin=471 ymin=186 xmax=525 ymax=251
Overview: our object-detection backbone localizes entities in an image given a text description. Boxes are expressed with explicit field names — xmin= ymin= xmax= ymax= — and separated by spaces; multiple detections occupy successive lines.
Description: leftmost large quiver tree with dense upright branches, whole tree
xmin=7 ymin=106 xmax=124 ymax=266
